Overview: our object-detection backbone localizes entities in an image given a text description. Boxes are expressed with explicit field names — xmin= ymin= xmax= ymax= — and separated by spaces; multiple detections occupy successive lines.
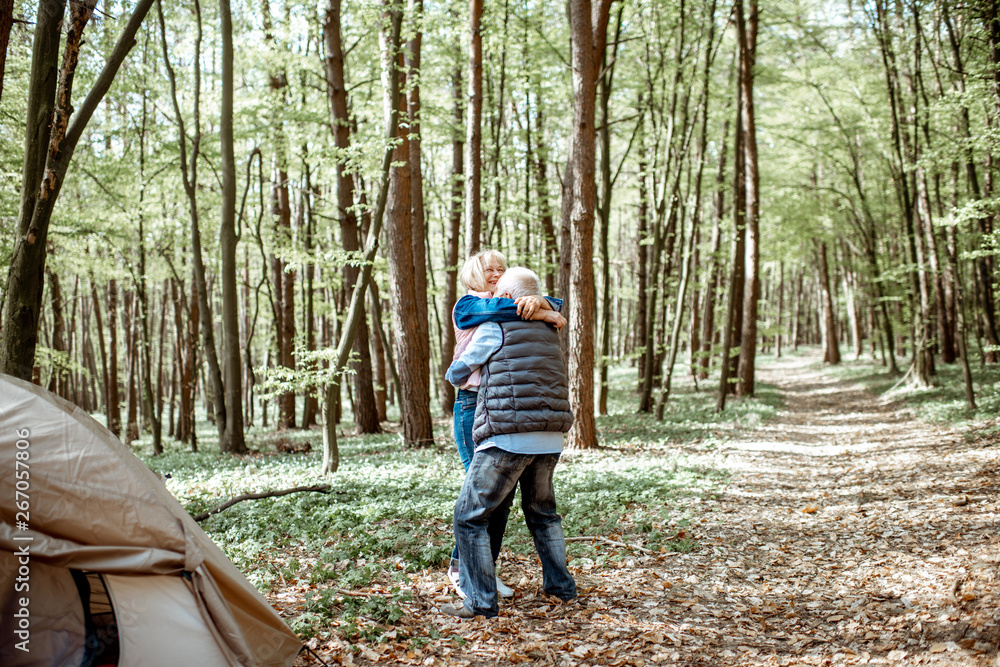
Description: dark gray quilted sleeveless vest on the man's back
xmin=472 ymin=322 xmax=573 ymax=443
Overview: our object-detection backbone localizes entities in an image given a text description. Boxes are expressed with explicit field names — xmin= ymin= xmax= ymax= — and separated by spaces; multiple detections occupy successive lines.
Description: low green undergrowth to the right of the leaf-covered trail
xmin=830 ymin=354 xmax=1000 ymax=441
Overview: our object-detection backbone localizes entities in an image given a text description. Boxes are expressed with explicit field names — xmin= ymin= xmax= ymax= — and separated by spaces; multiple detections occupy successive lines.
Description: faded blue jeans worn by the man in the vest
xmin=455 ymin=447 xmax=576 ymax=617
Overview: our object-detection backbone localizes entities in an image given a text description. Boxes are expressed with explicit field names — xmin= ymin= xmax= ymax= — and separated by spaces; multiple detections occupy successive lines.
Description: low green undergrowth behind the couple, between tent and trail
xmin=137 ymin=367 xmax=778 ymax=640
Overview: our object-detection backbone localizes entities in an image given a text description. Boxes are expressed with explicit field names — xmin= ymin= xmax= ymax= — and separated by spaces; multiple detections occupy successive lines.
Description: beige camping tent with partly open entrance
xmin=0 ymin=375 xmax=301 ymax=667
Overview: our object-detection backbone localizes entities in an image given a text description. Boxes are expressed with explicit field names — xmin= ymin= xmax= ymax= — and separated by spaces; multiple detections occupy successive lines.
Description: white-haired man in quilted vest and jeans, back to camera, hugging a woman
xmin=441 ymin=267 xmax=576 ymax=618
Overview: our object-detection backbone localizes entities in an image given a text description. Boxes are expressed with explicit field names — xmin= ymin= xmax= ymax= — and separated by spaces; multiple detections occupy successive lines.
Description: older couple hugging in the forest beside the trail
xmin=441 ymin=250 xmax=576 ymax=618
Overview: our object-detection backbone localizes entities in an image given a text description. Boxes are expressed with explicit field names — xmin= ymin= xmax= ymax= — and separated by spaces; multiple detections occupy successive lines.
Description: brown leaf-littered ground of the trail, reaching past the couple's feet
xmin=294 ymin=357 xmax=1000 ymax=667
